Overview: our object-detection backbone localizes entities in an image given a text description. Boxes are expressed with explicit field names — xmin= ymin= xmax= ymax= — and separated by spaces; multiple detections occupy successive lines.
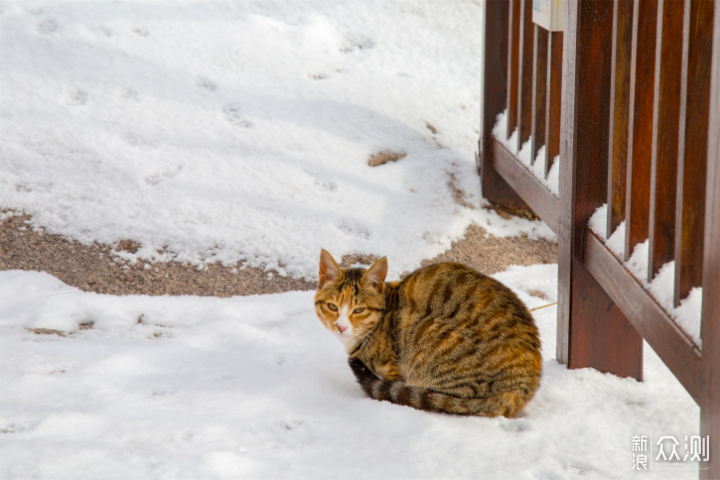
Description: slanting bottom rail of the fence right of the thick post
xmin=583 ymin=228 xmax=701 ymax=404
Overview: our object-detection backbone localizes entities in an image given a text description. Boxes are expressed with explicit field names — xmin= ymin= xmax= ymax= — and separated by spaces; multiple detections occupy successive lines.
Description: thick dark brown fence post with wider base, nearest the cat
xmin=557 ymin=0 xmax=643 ymax=380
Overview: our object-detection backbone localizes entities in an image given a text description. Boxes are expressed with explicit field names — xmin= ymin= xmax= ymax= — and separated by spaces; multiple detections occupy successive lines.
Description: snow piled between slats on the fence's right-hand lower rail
xmin=588 ymin=204 xmax=702 ymax=347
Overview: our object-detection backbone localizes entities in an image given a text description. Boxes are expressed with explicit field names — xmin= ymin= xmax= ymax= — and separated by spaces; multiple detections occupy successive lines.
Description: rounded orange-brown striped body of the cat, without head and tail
xmin=396 ymin=263 xmax=542 ymax=390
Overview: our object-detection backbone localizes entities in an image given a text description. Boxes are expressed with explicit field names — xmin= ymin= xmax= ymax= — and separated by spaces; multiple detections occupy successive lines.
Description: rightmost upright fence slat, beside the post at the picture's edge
xmin=674 ymin=0 xmax=715 ymax=307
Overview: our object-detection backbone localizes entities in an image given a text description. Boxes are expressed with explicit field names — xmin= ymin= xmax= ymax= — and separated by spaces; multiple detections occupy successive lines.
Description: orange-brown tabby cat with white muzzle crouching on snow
xmin=315 ymin=250 xmax=542 ymax=418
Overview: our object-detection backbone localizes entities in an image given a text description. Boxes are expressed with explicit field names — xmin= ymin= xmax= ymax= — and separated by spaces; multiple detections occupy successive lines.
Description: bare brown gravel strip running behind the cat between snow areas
xmin=0 ymin=211 xmax=557 ymax=297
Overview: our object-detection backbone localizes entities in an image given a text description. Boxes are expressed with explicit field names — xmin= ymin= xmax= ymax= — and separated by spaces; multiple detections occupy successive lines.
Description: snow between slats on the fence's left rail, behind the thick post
xmin=493 ymin=110 xmax=560 ymax=198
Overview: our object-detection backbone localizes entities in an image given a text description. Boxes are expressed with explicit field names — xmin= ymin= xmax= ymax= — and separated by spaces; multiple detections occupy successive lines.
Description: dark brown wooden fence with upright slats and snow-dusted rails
xmin=478 ymin=0 xmax=720 ymax=479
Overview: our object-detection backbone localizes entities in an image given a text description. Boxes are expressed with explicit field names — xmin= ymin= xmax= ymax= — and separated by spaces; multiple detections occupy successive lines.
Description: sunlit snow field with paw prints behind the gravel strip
xmin=0 ymin=0 xmax=555 ymax=278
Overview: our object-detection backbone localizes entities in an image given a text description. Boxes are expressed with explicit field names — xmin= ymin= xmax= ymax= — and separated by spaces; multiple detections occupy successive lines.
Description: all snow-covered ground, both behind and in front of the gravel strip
xmin=0 ymin=0 xmax=698 ymax=480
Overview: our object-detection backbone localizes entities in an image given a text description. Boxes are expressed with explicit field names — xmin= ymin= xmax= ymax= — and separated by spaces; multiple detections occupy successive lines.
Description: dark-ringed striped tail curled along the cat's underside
xmin=348 ymin=358 xmax=535 ymax=418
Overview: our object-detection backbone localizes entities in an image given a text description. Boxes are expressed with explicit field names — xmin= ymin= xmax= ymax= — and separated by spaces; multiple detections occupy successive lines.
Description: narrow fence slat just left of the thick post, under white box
xmin=545 ymin=32 xmax=563 ymax=178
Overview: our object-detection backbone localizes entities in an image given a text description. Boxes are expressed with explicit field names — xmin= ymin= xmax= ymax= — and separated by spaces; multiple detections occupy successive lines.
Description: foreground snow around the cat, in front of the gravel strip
xmin=0 ymin=265 xmax=699 ymax=479
